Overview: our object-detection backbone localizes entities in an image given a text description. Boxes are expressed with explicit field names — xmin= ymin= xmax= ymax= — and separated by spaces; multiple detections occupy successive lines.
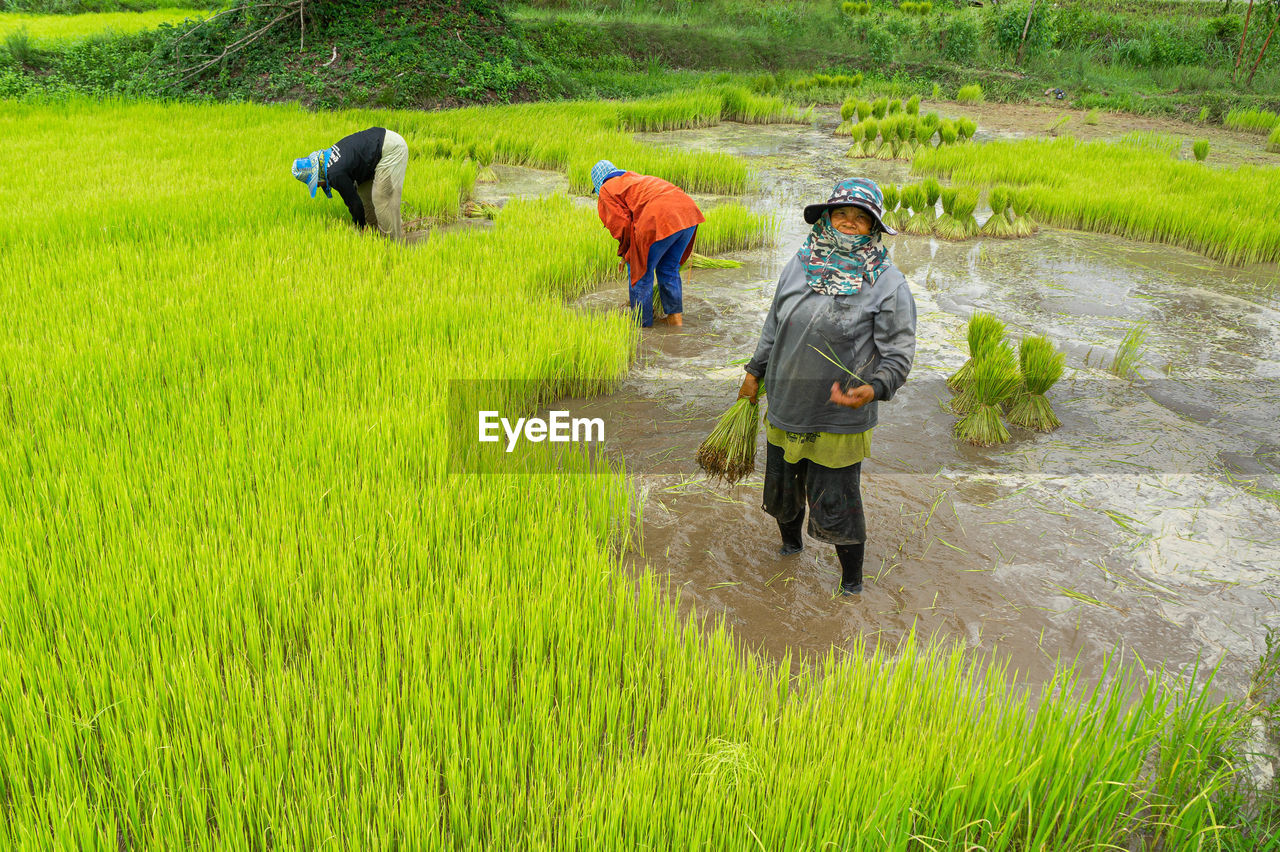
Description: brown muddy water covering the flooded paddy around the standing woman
xmin=488 ymin=116 xmax=1280 ymax=693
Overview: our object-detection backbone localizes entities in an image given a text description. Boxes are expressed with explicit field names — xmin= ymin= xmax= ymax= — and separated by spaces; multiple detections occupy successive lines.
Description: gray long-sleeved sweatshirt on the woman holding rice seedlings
xmin=746 ymin=257 xmax=915 ymax=435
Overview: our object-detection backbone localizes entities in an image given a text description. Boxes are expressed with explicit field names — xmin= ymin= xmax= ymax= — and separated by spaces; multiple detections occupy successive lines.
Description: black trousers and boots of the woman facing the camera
xmin=763 ymin=444 xmax=867 ymax=586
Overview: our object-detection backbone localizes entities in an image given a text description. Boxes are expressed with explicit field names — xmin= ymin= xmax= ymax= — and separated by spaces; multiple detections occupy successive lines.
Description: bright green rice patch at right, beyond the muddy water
xmin=913 ymin=137 xmax=1280 ymax=265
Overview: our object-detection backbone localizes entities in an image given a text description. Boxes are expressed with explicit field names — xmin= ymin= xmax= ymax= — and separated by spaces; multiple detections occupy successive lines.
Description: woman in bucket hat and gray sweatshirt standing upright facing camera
xmin=739 ymin=178 xmax=915 ymax=595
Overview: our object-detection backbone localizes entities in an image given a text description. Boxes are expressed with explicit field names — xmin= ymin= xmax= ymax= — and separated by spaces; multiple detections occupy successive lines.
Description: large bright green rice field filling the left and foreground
xmin=0 ymin=92 xmax=1259 ymax=851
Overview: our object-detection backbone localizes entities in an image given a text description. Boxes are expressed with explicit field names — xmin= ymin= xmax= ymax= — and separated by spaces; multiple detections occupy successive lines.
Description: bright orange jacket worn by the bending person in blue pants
xmin=596 ymin=171 xmax=707 ymax=284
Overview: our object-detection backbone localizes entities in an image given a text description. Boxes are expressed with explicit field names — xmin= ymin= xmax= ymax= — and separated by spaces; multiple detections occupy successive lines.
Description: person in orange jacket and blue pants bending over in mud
xmin=591 ymin=160 xmax=705 ymax=329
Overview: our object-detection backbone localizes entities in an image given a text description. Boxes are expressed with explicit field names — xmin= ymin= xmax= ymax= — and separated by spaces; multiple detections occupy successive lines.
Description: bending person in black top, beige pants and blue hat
xmin=293 ymin=127 xmax=408 ymax=239
